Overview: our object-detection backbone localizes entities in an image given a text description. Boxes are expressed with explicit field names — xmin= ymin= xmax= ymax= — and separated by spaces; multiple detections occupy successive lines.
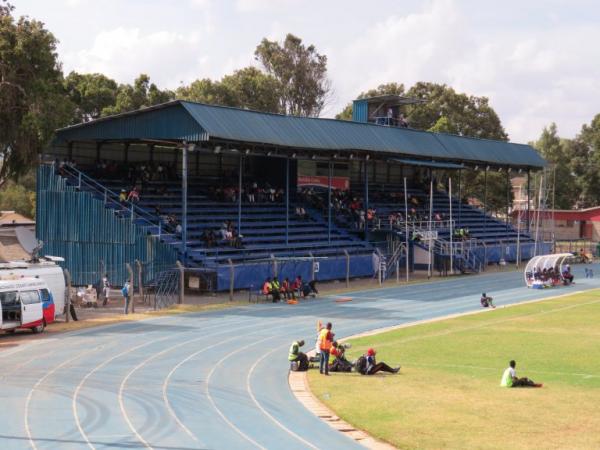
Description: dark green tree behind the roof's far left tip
xmin=64 ymin=72 xmax=118 ymax=123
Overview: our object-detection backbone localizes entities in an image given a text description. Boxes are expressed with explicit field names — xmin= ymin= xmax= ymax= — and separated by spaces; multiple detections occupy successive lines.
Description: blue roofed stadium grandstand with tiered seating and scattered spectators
xmin=37 ymin=96 xmax=545 ymax=290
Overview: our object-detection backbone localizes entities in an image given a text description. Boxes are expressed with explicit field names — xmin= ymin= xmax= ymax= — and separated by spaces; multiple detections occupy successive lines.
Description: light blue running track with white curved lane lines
xmin=0 ymin=266 xmax=600 ymax=450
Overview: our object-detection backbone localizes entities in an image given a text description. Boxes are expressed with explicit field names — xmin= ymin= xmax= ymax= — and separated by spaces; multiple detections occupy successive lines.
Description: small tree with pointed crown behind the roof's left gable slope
xmin=102 ymin=74 xmax=175 ymax=116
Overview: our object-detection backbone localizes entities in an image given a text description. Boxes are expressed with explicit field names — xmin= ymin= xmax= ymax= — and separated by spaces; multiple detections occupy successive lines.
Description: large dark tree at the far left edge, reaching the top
xmin=0 ymin=0 xmax=73 ymax=186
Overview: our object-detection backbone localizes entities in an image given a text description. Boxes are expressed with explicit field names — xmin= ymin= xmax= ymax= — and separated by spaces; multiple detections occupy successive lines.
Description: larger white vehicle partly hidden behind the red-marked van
xmin=0 ymin=257 xmax=66 ymax=316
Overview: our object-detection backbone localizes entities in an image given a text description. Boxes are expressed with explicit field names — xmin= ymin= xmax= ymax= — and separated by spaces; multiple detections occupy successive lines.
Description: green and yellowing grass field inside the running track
xmin=309 ymin=291 xmax=600 ymax=449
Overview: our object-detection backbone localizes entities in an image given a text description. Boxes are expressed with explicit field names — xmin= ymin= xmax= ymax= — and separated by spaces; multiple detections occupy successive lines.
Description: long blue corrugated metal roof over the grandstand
xmin=57 ymin=100 xmax=545 ymax=168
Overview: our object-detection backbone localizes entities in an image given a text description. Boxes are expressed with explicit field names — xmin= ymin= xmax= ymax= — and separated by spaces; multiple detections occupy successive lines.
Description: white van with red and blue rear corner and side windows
xmin=0 ymin=276 xmax=55 ymax=333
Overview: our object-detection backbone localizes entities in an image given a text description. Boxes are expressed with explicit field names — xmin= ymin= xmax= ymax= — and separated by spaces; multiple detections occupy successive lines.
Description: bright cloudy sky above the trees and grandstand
xmin=11 ymin=0 xmax=600 ymax=142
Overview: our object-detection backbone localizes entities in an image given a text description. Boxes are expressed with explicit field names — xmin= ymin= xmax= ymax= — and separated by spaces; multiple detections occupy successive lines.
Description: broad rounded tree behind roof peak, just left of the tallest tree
xmin=176 ymin=67 xmax=281 ymax=113
